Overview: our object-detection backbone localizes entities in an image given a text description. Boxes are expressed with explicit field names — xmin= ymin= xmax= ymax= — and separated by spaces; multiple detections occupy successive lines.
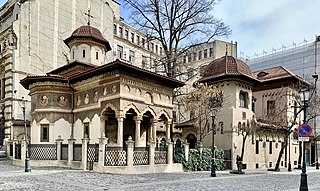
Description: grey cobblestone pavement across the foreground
xmin=0 ymin=160 xmax=320 ymax=191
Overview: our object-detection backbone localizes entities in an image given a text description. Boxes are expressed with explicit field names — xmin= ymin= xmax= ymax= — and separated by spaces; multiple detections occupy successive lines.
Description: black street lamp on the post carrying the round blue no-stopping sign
xmin=300 ymin=88 xmax=309 ymax=191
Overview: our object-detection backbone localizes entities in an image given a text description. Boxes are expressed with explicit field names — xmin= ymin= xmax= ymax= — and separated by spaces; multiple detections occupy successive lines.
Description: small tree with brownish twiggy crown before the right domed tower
xmin=180 ymin=84 xmax=223 ymax=143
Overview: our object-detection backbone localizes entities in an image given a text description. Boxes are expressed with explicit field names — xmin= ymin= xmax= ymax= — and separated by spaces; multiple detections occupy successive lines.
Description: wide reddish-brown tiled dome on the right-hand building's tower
xmin=200 ymin=55 xmax=256 ymax=81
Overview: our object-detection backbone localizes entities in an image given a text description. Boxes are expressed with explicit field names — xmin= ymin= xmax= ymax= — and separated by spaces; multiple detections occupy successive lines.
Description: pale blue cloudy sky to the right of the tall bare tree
xmin=0 ymin=0 xmax=320 ymax=57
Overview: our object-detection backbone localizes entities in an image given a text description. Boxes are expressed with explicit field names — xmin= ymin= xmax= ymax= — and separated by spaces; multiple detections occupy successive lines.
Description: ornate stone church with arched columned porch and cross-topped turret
xmin=20 ymin=25 xmax=184 ymax=173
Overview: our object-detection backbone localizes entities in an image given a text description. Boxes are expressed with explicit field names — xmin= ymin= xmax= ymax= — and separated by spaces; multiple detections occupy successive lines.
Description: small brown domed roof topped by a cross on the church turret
xmin=64 ymin=25 xmax=111 ymax=51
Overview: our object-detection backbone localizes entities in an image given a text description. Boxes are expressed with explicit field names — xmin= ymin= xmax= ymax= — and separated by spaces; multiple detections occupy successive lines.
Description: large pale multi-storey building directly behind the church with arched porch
xmin=0 ymin=0 xmax=236 ymax=144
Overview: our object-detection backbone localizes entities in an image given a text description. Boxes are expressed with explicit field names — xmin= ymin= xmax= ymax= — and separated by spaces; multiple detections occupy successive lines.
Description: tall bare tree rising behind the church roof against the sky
xmin=123 ymin=0 xmax=231 ymax=78
